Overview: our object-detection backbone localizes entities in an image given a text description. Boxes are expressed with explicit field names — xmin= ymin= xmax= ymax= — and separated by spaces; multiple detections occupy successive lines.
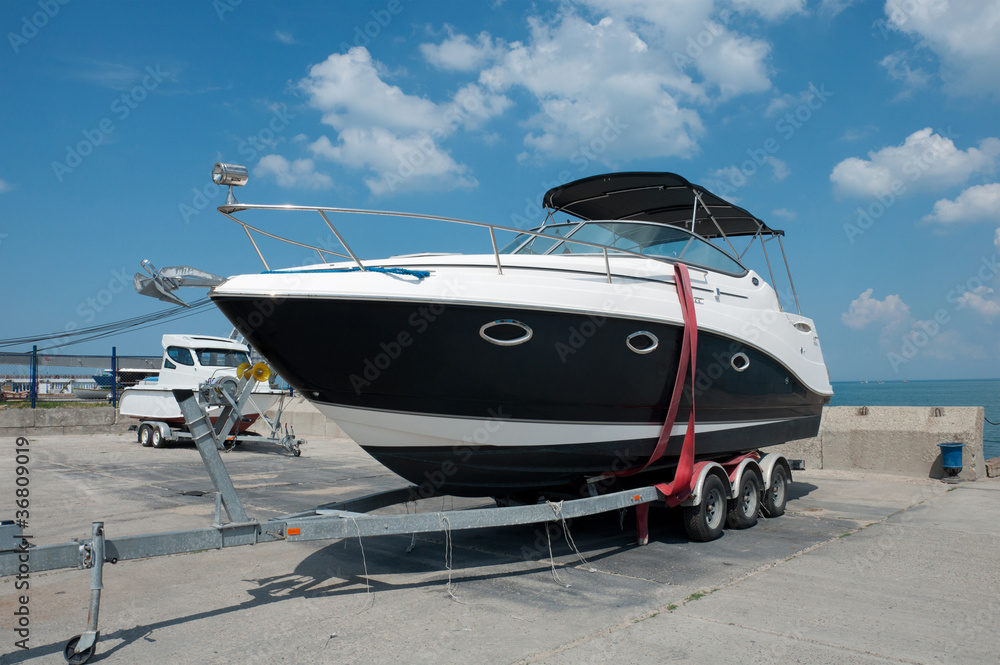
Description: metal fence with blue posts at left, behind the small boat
xmin=0 ymin=347 xmax=161 ymax=409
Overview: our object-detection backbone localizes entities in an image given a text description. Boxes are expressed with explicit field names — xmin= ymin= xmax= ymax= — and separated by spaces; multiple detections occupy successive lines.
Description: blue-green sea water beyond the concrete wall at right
xmin=830 ymin=379 xmax=1000 ymax=459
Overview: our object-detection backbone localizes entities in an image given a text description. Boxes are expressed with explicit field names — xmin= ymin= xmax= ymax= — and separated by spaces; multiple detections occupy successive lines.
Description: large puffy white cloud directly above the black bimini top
xmin=479 ymin=15 xmax=704 ymax=165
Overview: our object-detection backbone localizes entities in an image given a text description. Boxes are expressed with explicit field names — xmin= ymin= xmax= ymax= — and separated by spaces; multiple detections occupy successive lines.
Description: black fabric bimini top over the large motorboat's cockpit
xmin=543 ymin=172 xmax=785 ymax=238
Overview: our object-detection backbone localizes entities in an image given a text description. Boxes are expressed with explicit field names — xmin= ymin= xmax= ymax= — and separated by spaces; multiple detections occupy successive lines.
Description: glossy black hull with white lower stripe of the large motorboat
xmin=213 ymin=295 xmax=829 ymax=496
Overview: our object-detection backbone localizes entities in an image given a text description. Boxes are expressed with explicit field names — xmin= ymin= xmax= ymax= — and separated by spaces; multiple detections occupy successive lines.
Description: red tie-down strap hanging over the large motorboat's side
xmin=620 ymin=263 xmax=698 ymax=543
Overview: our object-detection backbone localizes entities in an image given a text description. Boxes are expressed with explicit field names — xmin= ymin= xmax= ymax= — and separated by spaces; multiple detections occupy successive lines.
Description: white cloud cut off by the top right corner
xmin=885 ymin=0 xmax=1000 ymax=94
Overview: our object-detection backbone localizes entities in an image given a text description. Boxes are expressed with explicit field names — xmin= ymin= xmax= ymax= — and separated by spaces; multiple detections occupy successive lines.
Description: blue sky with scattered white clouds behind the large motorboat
xmin=0 ymin=0 xmax=1000 ymax=380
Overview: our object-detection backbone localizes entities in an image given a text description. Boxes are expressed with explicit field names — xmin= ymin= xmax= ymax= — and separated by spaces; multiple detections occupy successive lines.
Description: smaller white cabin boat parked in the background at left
xmin=118 ymin=335 xmax=282 ymax=434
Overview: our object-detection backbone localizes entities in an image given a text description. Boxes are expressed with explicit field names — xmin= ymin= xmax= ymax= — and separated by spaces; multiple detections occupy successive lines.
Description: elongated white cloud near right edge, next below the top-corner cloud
xmin=830 ymin=127 xmax=1000 ymax=197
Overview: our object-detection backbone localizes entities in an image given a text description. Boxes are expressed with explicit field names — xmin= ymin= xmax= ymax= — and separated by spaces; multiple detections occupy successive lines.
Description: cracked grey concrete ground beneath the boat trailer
xmin=0 ymin=435 xmax=1000 ymax=665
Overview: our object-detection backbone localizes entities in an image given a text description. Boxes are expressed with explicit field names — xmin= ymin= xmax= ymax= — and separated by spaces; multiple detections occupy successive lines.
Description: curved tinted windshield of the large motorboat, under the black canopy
xmin=504 ymin=221 xmax=746 ymax=275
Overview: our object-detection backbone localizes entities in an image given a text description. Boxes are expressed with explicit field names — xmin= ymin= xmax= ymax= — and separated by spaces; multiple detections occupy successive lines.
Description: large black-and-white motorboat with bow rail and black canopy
xmin=137 ymin=164 xmax=832 ymax=496
